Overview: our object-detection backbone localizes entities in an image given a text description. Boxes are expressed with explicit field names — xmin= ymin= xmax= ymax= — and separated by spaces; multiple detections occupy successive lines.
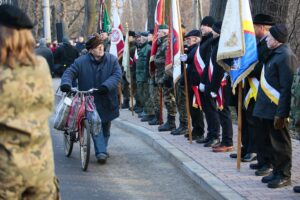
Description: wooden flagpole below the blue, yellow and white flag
xmin=236 ymin=82 xmax=242 ymax=170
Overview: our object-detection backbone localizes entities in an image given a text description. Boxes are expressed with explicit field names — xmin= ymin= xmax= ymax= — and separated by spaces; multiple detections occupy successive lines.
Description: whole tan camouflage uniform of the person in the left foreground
xmin=0 ymin=57 xmax=59 ymax=200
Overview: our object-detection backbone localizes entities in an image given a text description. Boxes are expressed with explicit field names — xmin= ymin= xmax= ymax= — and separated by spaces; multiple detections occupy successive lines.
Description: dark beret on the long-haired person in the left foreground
xmin=0 ymin=4 xmax=33 ymax=29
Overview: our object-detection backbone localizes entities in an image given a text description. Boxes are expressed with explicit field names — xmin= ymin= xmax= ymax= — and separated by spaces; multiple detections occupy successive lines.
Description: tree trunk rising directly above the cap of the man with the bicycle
xmin=81 ymin=0 xmax=97 ymax=37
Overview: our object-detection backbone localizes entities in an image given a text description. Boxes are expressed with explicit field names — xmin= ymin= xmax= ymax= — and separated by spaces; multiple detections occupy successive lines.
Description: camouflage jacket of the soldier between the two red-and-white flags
xmin=154 ymin=35 xmax=168 ymax=84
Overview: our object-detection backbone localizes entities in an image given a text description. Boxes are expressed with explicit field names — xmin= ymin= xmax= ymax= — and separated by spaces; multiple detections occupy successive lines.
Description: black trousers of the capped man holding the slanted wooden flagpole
xmin=188 ymin=90 xmax=204 ymax=136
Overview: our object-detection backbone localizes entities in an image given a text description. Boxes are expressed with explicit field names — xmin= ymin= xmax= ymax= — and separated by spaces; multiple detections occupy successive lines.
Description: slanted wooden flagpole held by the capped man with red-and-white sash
xmin=176 ymin=0 xmax=192 ymax=144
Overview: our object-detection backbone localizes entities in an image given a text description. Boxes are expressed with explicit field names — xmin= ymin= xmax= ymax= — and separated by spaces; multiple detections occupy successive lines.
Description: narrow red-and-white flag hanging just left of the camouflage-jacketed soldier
xmin=149 ymin=0 xmax=165 ymax=75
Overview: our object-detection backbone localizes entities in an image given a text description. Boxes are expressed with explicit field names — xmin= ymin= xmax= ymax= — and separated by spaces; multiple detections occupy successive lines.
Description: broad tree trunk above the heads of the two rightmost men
xmin=252 ymin=0 xmax=290 ymax=23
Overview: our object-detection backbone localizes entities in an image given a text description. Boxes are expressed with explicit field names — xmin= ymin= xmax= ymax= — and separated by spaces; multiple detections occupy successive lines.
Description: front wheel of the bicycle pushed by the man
xmin=79 ymin=119 xmax=91 ymax=171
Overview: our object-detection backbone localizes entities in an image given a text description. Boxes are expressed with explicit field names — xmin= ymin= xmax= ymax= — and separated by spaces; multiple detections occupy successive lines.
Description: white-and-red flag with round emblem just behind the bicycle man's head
xmin=109 ymin=8 xmax=124 ymax=59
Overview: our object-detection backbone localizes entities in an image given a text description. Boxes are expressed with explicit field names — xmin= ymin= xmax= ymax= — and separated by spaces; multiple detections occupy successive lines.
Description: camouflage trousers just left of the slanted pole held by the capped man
xmin=176 ymin=81 xmax=188 ymax=124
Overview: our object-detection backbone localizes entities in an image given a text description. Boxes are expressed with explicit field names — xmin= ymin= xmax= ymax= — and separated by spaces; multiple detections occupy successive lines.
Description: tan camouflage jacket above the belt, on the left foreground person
xmin=0 ymin=57 xmax=54 ymax=137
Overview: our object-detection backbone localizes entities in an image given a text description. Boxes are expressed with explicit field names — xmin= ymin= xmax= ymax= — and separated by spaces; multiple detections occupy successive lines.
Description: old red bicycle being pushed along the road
xmin=64 ymin=88 xmax=97 ymax=171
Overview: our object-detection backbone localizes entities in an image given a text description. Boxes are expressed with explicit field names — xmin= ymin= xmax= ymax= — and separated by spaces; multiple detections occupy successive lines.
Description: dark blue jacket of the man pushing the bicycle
xmin=61 ymin=53 xmax=122 ymax=122
